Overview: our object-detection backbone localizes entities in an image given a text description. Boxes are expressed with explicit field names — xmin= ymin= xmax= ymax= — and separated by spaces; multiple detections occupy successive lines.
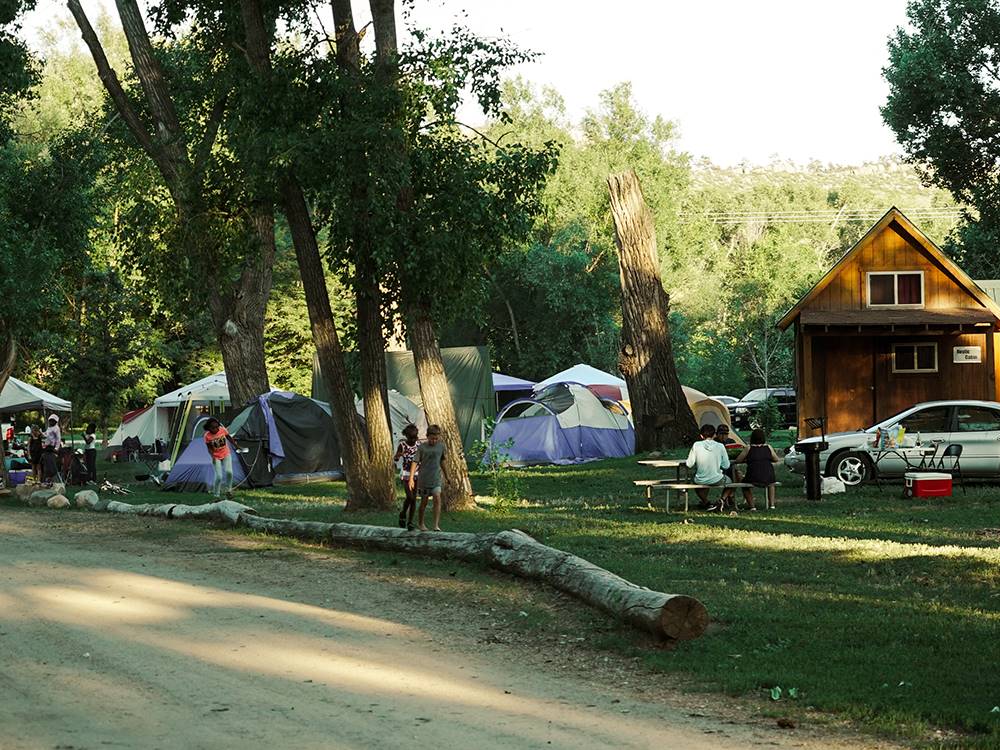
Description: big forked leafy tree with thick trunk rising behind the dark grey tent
xmin=67 ymin=0 xmax=274 ymax=403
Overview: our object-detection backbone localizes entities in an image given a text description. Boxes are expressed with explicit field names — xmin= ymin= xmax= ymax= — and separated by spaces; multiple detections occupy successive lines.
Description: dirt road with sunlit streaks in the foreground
xmin=0 ymin=507 xmax=900 ymax=750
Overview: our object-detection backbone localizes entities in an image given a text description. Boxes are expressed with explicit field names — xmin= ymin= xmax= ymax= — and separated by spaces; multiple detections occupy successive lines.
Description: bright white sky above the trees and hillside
xmin=23 ymin=0 xmax=906 ymax=165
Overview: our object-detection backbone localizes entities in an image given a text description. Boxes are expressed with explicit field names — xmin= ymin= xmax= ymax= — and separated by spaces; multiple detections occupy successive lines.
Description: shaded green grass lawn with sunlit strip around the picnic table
xmin=23 ymin=444 xmax=1000 ymax=747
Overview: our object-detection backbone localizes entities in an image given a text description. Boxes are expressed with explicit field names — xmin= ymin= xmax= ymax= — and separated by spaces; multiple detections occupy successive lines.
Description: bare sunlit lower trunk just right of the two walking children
xmin=408 ymin=306 xmax=475 ymax=510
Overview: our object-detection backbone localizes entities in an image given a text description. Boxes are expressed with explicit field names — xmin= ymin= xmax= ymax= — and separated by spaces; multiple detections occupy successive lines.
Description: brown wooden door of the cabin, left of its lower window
xmin=817 ymin=336 xmax=875 ymax=432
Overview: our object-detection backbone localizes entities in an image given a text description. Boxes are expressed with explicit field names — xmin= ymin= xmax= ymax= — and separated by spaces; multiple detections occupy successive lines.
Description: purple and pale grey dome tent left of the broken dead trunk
xmin=490 ymin=383 xmax=635 ymax=465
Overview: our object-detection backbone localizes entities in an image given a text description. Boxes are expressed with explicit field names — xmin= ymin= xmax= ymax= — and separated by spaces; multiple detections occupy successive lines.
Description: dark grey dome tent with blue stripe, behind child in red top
xmin=229 ymin=391 xmax=344 ymax=487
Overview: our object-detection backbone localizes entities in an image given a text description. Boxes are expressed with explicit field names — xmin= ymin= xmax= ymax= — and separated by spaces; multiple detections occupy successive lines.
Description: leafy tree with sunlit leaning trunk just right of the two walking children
xmin=354 ymin=0 xmax=555 ymax=508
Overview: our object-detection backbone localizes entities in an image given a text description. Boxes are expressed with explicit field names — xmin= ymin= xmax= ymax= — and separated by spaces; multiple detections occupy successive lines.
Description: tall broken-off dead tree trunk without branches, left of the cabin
xmin=608 ymin=171 xmax=698 ymax=453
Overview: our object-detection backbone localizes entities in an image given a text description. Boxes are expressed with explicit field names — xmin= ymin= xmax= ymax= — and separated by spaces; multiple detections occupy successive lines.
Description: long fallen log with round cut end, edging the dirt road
xmin=240 ymin=516 xmax=708 ymax=640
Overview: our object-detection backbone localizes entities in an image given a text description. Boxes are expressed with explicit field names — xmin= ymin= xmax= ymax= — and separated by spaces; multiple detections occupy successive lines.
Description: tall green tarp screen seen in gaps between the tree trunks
xmin=312 ymin=346 xmax=496 ymax=451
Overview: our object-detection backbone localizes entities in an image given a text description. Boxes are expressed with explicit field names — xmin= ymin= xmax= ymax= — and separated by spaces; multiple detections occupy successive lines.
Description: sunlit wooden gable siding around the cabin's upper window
xmin=808 ymin=223 xmax=985 ymax=318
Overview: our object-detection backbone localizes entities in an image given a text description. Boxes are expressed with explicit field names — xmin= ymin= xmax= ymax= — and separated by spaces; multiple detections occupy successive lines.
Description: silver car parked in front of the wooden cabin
xmin=785 ymin=401 xmax=1000 ymax=485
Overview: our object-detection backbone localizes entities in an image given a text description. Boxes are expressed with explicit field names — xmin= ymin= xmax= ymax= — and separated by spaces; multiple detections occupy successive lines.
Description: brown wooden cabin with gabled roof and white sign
xmin=778 ymin=208 xmax=1000 ymax=436
